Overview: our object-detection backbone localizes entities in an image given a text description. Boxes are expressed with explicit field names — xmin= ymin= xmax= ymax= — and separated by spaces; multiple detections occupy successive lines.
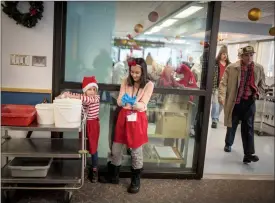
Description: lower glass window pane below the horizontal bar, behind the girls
xmin=64 ymin=91 xmax=199 ymax=171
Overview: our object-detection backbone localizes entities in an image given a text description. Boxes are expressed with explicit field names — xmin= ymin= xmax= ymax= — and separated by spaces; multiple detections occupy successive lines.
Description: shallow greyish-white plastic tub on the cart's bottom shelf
xmin=8 ymin=157 xmax=53 ymax=178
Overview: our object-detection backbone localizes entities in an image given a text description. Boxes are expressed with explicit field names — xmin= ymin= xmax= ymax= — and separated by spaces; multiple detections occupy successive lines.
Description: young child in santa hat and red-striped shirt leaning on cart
xmin=59 ymin=76 xmax=100 ymax=183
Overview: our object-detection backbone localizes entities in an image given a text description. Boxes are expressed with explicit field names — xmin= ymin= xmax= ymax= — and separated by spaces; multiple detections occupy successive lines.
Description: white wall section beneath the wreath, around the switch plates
xmin=1 ymin=1 xmax=54 ymax=89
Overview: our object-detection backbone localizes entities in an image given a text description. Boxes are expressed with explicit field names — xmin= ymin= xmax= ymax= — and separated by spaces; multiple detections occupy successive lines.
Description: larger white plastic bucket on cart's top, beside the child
xmin=53 ymin=98 xmax=82 ymax=128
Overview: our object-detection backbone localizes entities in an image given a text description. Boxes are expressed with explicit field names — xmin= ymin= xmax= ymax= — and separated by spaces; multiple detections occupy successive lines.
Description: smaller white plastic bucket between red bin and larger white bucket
xmin=35 ymin=103 xmax=54 ymax=125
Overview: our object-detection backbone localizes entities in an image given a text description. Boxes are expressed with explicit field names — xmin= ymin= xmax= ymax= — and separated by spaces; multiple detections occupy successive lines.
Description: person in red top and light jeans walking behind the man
xmin=211 ymin=46 xmax=230 ymax=128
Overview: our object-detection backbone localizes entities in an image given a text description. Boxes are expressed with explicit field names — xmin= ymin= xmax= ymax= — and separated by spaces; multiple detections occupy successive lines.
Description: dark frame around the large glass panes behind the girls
xmin=52 ymin=1 xmax=221 ymax=179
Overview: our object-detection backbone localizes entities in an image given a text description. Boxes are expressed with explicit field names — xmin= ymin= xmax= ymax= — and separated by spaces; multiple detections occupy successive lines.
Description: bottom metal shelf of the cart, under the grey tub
xmin=1 ymin=159 xmax=81 ymax=184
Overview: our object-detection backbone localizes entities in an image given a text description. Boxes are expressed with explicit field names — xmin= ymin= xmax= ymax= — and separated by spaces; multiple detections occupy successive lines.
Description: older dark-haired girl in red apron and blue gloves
xmin=99 ymin=58 xmax=154 ymax=193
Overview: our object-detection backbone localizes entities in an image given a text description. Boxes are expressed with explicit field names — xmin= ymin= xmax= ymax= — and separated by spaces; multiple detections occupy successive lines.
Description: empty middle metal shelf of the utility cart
xmin=1 ymin=138 xmax=81 ymax=158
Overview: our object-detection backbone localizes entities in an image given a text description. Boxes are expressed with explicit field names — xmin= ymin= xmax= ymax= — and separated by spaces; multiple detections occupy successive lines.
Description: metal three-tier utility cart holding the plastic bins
xmin=1 ymin=119 xmax=87 ymax=202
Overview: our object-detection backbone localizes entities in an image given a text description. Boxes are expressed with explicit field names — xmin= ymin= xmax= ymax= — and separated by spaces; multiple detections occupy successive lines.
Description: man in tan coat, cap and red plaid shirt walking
xmin=218 ymin=46 xmax=265 ymax=163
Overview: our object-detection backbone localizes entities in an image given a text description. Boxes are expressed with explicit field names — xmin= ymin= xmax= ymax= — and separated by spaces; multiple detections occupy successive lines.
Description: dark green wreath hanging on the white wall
xmin=1 ymin=1 xmax=44 ymax=28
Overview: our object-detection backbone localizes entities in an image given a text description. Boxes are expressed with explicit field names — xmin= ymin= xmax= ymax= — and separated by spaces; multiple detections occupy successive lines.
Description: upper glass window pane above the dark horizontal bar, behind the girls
xmin=65 ymin=1 xmax=211 ymax=89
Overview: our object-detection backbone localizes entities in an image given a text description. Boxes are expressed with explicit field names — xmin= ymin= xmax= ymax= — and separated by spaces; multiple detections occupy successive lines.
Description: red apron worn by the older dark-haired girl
xmin=114 ymin=108 xmax=148 ymax=149
